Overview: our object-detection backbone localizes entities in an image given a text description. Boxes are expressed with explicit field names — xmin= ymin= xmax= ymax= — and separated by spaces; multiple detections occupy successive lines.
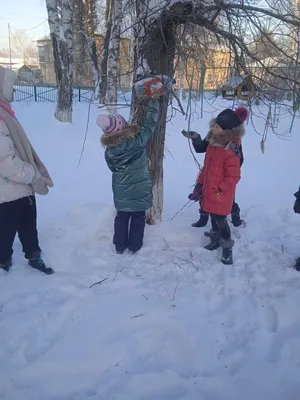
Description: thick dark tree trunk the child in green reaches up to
xmin=132 ymin=1 xmax=175 ymax=225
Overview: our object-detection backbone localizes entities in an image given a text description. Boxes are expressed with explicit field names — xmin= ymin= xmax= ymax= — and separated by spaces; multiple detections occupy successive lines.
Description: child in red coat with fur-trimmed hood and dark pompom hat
xmin=183 ymin=107 xmax=248 ymax=264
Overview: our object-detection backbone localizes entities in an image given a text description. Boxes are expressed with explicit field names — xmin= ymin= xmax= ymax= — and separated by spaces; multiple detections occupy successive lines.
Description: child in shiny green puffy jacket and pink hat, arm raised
xmin=97 ymin=99 xmax=159 ymax=254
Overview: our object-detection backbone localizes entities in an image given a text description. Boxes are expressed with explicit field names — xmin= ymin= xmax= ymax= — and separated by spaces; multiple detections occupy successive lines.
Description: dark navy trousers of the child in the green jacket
xmin=113 ymin=211 xmax=146 ymax=252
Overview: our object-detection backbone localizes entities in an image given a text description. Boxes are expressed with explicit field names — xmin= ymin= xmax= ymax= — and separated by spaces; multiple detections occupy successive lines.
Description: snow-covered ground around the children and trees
xmin=0 ymin=97 xmax=300 ymax=400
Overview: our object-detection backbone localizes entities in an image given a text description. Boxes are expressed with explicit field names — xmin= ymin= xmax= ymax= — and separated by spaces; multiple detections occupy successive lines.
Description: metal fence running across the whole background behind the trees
xmin=15 ymin=66 xmax=300 ymax=106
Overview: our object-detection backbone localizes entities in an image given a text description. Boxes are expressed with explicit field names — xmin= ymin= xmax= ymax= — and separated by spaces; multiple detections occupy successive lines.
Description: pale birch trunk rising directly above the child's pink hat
xmin=106 ymin=0 xmax=122 ymax=113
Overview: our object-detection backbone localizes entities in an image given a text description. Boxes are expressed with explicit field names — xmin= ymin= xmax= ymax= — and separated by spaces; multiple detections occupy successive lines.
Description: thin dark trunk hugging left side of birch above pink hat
xmin=99 ymin=0 xmax=112 ymax=104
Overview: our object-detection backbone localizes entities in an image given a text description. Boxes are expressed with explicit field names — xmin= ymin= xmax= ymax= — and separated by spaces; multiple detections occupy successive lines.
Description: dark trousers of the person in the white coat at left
xmin=0 ymin=196 xmax=41 ymax=263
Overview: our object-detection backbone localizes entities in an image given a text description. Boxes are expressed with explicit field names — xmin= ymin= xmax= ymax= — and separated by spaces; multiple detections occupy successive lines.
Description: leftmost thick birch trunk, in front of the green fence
xmin=46 ymin=0 xmax=73 ymax=122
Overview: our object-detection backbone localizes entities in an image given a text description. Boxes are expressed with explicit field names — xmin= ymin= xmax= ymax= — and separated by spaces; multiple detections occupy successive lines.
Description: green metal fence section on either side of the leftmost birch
xmin=14 ymin=83 xmax=94 ymax=103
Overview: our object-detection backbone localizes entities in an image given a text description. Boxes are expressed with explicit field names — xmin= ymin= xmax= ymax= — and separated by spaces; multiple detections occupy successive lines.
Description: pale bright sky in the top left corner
xmin=0 ymin=0 xmax=49 ymax=49
